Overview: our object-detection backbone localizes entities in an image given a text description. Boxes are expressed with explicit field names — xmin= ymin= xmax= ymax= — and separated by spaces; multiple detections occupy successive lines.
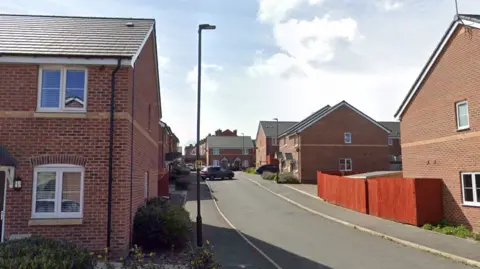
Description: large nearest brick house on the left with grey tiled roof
xmin=0 ymin=15 xmax=162 ymax=252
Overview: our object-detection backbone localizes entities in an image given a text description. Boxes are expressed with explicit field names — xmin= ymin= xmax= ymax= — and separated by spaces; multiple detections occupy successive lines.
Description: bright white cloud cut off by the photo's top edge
xmin=257 ymin=0 xmax=324 ymax=22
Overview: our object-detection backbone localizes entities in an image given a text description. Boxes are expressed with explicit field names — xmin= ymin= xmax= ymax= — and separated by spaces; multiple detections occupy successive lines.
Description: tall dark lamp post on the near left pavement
xmin=195 ymin=24 xmax=216 ymax=247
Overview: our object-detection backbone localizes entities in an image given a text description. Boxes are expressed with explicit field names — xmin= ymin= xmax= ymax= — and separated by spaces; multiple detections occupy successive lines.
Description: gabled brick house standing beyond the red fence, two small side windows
xmin=276 ymin=101 xmax=390 ymax=183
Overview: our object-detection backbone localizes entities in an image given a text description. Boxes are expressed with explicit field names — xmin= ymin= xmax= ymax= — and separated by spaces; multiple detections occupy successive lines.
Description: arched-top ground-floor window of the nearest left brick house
xmin=32 ymin=165 xmax=84 ymax=218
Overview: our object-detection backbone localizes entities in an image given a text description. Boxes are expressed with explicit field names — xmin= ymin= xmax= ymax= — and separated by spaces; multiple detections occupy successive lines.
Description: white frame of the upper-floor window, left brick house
xmin=37 ymin=65 xmax=88 ymax=113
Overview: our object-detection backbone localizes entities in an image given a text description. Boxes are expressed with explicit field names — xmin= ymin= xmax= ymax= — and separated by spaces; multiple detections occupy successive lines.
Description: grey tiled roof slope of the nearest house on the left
xmin=0 ymin=14 xmax=155 ymax=58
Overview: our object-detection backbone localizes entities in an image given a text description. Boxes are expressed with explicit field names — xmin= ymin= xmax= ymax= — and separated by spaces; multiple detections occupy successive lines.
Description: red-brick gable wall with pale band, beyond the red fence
xmin=298 ymin=103 xmax=389 ymax=183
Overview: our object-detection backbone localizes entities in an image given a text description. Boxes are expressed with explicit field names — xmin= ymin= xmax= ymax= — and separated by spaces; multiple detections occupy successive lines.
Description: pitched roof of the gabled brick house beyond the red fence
xmin=280 ymin=101 xmax=390 ymax=136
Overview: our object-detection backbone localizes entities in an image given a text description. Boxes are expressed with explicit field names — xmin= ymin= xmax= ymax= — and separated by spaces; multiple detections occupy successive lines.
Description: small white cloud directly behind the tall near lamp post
xmin=187 ymin=64 xmax=223 ymax=92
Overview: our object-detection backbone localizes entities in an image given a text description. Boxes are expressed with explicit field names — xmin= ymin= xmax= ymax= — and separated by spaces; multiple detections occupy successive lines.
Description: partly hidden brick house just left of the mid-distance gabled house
xmin=255 ymin=121 xmax=297 ymax=167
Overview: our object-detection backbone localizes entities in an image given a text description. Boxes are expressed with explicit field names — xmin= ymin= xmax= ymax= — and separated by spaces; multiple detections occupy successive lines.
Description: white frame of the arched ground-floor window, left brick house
xmin=32 ymin=164 xmax=85 ymax=219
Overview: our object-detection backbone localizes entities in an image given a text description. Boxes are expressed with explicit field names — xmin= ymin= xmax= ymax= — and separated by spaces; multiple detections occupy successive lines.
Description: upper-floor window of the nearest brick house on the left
xmin=37 ymin=68 xmax=87 ymax=112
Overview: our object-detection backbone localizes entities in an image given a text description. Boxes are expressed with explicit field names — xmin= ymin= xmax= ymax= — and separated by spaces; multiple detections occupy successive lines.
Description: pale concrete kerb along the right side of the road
xmin=237 ymin=175 xmax=480 ymax=268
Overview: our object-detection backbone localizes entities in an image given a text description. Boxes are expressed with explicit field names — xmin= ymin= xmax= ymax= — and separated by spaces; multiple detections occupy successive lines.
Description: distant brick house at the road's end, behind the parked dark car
xmin=205 ymin=130 xmax=255 ymax=169
